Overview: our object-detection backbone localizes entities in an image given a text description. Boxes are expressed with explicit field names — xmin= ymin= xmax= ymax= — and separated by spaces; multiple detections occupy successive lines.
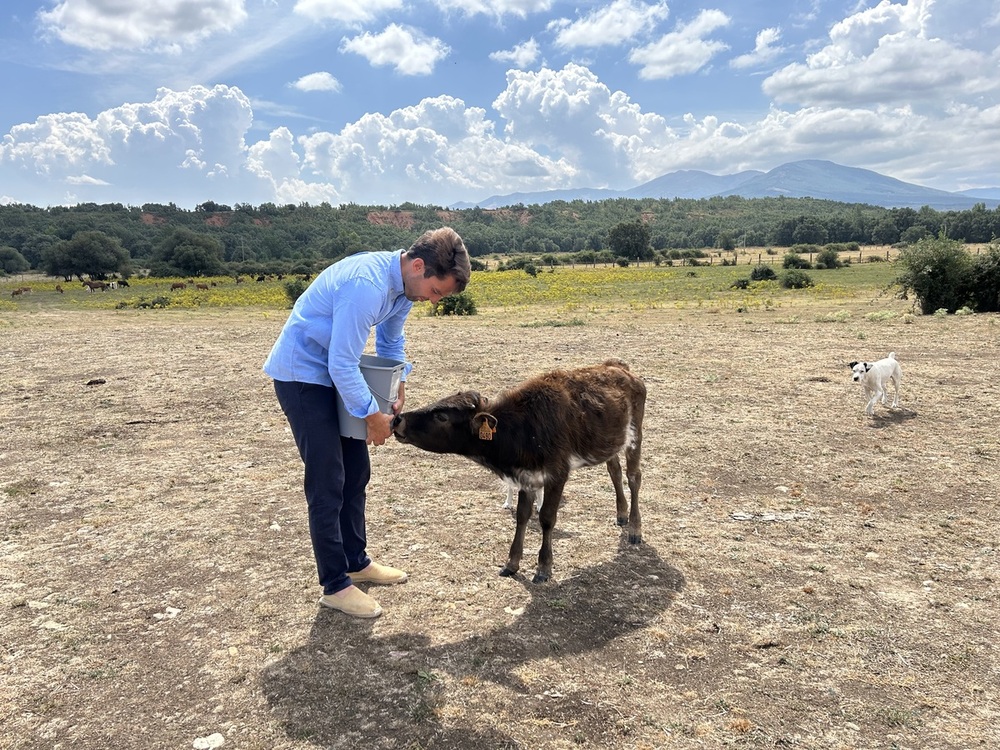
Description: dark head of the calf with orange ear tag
xmin=392 ymin=391 xmax=497 ymax=453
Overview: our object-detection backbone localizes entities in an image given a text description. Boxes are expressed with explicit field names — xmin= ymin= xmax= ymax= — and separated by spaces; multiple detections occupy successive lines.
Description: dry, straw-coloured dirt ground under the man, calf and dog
xmin=0 ymin=303 xmax=1000 ymax=750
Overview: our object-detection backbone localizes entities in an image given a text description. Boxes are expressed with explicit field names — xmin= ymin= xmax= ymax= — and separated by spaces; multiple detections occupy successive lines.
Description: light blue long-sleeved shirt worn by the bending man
xmin=264 ymin=250 xmax=413 ymax=418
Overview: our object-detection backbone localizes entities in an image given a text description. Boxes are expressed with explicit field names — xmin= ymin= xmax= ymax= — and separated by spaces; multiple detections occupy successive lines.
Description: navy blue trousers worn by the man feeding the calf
xmin=274 ymin=380 xmax=371 ymax=594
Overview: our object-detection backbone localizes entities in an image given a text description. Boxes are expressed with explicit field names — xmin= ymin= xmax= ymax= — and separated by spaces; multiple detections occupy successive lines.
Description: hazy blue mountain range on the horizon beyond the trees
xmin=452 ymin=159 xmax=1000 ymax=211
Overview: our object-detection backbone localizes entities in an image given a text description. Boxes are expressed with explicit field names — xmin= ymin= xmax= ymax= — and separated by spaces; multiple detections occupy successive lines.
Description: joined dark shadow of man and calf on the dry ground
xmin=262 ymin=545 xmax=684 ymax=750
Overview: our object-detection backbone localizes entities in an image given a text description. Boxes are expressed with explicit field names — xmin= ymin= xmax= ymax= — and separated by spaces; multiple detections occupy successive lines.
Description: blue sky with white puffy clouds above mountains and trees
xmin=0 ymin=0 xmax=1000 ymax=208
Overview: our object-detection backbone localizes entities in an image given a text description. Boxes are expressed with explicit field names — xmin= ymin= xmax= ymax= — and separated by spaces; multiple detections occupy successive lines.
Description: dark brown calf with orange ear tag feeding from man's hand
xmin=392 ymin=359 xmax=646 ymax=583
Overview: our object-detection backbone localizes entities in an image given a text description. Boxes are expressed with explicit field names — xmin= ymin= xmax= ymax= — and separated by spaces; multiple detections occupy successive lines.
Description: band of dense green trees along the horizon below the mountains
xmin=0 ymin=196 xmax=1000 ymax=278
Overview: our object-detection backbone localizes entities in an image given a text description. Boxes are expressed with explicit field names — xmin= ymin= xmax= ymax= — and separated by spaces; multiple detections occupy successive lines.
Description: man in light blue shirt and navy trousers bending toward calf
xmin=264 ymin=227 xmax=470 ymax=617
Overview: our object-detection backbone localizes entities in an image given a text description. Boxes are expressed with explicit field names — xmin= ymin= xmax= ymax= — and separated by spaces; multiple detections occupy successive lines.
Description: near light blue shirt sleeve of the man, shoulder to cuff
xmin=329 ymin=278 xmax=383 ymax=419
